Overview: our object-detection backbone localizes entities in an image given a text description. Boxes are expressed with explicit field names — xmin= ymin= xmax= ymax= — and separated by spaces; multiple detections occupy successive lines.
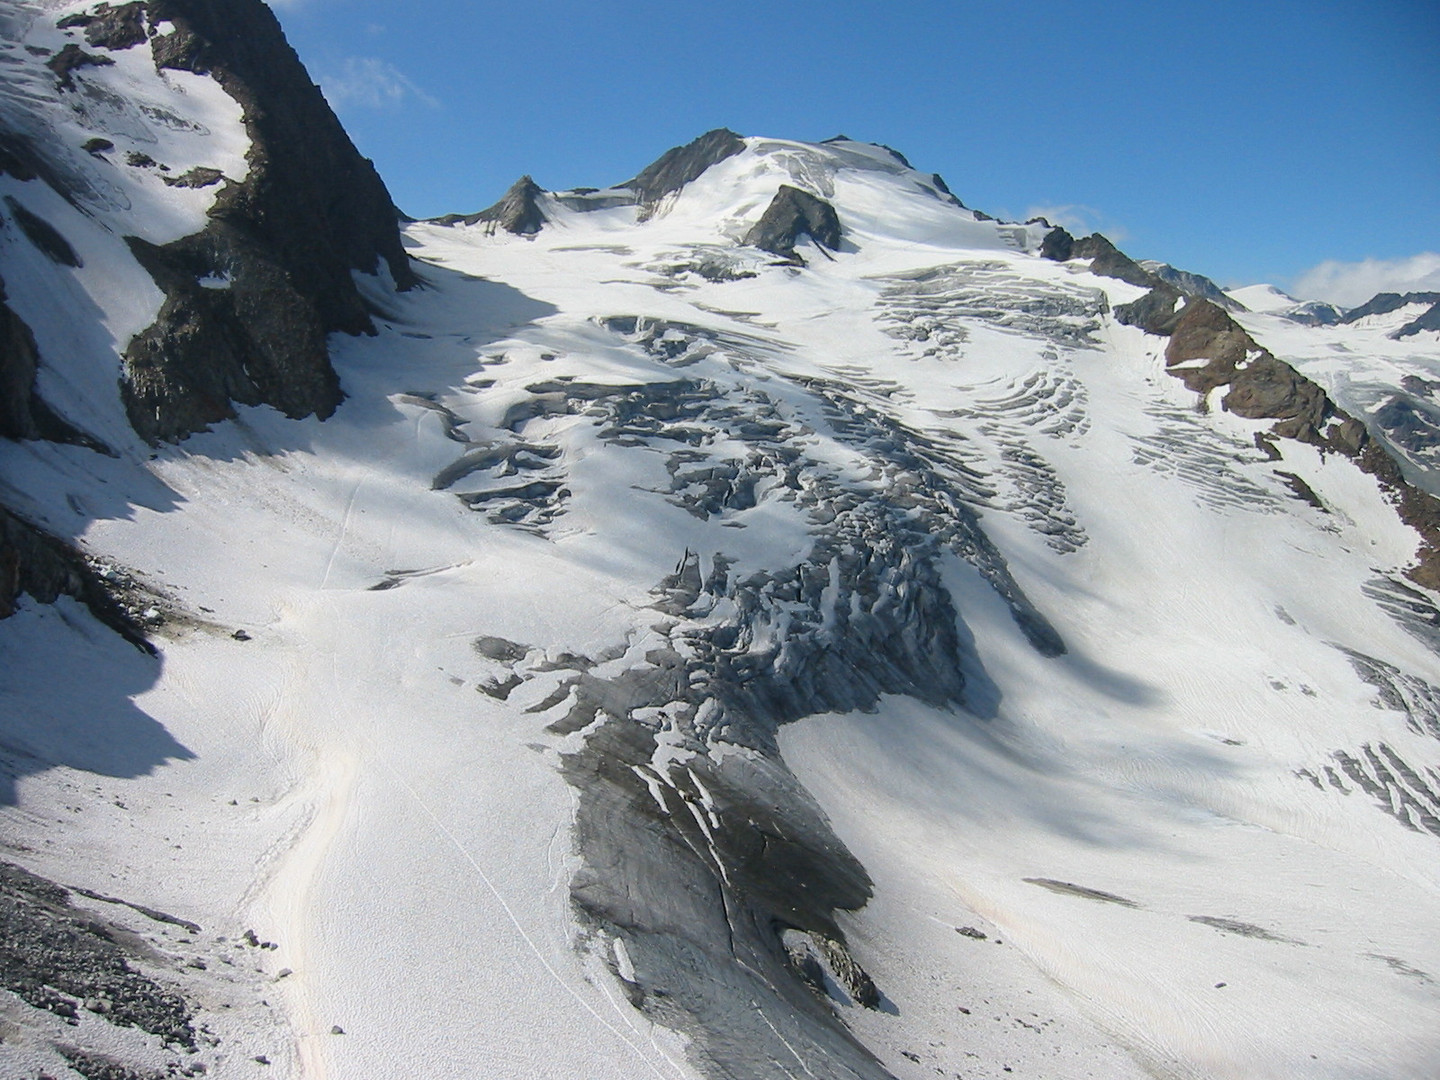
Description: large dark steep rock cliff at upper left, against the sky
xmin=110 ymin=0 xmax=415 ymax=441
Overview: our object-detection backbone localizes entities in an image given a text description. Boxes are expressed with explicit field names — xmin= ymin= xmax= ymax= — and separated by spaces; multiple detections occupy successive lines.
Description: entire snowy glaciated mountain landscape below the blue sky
xmin=0 ymin=0 xmax=1440 ymax=1080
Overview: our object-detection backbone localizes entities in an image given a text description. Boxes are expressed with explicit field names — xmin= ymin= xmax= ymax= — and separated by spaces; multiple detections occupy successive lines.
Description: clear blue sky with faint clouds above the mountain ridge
xmin=264 ymin=0 xmax=1440 ymax=302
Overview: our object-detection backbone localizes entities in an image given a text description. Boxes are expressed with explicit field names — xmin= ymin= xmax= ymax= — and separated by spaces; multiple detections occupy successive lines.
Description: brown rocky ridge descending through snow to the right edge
xmin=1116 ymin=292 xmax=1440 ymax=589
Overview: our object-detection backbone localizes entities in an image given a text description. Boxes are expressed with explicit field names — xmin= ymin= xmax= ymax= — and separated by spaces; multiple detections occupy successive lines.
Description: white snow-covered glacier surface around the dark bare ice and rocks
xmin=0 ymin=128 xmax=1440 ymax=1080
